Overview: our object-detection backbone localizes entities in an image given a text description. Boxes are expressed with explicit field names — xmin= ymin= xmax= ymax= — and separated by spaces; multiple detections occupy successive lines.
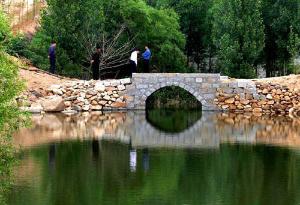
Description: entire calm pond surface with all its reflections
xmin=8 ymin=110 xmax=300 ymax=205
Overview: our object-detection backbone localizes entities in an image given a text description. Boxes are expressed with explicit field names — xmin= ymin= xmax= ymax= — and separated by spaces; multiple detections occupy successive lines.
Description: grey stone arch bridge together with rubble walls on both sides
xmin=17 ymin=73 xmax=300 ymax=116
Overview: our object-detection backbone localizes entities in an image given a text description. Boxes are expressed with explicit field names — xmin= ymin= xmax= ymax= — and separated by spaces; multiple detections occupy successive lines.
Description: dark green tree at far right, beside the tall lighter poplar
xmin=262 ymin=0 xmax=300 ymax=77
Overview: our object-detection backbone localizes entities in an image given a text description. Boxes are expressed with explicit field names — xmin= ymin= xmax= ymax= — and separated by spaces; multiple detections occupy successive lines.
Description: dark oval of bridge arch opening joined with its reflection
xmin=146 ymin=86 xmax=202 ymax=134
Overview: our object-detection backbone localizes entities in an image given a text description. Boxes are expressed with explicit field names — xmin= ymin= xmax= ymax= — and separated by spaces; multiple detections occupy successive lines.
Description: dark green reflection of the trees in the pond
xmin=9 ymin=141 xmax=300 ymax=205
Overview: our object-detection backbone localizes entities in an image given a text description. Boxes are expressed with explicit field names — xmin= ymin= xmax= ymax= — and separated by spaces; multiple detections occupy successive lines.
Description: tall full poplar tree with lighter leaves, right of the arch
xmin=212 ymin=0 xmax=264 ymax=78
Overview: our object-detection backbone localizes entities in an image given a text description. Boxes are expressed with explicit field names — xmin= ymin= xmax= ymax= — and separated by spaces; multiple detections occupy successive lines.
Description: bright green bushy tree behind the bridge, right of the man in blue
xmin=121 ymin=0 xmax=187 ymax=72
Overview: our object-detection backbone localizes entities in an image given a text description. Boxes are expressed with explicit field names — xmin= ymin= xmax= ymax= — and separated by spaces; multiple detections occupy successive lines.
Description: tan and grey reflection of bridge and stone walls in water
xmin=14 ymin=111 xmax=300 ymax=148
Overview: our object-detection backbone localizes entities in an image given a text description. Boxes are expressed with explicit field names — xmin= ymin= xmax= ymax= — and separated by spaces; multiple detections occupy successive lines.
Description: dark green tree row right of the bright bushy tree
xmin=147 ymin=0 xmax=300 ymax=77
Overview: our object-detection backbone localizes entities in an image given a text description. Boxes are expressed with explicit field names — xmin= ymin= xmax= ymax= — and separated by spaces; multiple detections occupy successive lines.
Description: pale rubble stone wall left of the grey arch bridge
xmin=17 ymin=78 xmax=131 ymax=113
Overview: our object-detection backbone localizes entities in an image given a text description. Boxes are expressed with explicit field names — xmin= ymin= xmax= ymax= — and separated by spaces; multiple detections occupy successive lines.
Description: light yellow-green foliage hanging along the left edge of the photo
xmin=0 ymin=7 xmax=22 ymax=204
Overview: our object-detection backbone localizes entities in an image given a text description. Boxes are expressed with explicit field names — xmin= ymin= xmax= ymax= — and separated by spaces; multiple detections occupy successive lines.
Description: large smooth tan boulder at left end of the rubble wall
xmin=41 ymin=95 xmax=65 ymax=112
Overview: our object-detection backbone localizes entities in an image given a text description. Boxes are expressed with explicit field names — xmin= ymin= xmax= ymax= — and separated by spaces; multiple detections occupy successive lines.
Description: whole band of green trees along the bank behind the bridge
xmin=4 ymin=0 xmax=300 ymax=78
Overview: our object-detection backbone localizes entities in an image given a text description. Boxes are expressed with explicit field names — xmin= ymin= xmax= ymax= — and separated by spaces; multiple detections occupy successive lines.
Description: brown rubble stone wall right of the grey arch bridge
xmin=215 ymin=76 xmax=300 ymax=116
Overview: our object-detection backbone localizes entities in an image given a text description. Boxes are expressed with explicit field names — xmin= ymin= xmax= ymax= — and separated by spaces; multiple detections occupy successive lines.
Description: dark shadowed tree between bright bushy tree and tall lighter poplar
xmin=148 ymin=0 xmax=214 ymax=71
